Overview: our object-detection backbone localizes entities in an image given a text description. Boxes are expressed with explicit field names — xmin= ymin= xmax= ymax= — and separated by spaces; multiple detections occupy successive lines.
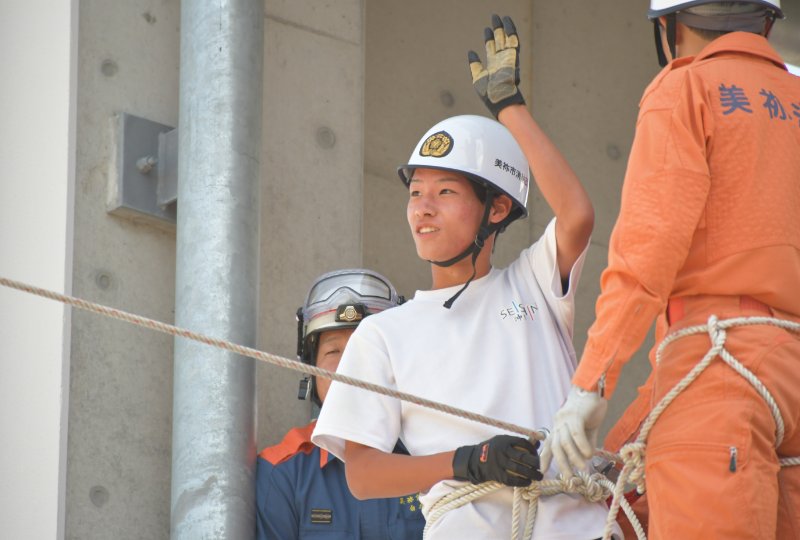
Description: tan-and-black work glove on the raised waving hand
xmin=467 ymin=15 xmax=525 ymax=118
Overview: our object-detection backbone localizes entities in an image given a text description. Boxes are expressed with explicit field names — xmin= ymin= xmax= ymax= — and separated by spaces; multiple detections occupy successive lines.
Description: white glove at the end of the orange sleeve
xmin=541 ymin=386 xmax=608 ymax=478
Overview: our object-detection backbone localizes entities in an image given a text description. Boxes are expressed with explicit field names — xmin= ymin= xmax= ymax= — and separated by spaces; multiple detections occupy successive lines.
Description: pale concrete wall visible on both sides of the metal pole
xmin=59 ymin=0 xmax=363 ymax=538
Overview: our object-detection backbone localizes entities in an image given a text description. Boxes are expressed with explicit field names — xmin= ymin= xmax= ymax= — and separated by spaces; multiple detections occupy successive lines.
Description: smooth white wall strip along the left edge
xmin=0 ymin=0 xmax=77 ymax=539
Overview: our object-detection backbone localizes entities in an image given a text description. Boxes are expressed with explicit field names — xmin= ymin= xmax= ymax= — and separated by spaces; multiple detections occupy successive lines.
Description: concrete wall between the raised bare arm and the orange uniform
xmin=532 ymin=0 xmax=659 ymax=436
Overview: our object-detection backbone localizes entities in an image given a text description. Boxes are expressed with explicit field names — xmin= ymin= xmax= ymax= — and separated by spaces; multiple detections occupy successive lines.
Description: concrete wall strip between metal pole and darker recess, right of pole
xmin=256 ymin=0 xmax=364 ymax=450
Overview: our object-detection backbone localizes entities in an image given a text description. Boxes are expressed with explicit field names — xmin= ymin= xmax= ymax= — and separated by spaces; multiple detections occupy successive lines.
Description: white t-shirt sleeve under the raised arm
xmin=527 ymin=218 xmax=589 ymax=339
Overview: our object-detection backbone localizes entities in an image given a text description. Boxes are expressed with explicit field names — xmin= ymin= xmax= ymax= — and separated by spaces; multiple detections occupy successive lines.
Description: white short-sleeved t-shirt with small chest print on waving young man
xmin=312 ymin=220 xmax=620 ymax=540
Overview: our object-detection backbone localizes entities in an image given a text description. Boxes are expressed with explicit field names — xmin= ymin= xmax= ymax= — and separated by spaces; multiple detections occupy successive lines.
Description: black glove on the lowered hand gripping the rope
xmin=453 ymin=435 xmax=542 ymax=487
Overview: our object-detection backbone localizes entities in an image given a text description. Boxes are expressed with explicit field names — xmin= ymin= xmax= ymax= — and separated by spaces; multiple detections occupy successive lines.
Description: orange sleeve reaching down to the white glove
xmin=573 ymin=68 xmax=713 ymax=397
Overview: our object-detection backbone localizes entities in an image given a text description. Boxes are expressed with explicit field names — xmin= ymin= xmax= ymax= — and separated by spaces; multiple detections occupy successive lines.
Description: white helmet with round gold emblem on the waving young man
xmin=397 ymin=115 xmax=530 ymax=226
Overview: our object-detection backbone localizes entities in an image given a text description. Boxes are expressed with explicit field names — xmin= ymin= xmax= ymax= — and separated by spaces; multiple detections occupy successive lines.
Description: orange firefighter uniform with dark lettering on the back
xmin=573 ymin=32 xmax=800 ymax=538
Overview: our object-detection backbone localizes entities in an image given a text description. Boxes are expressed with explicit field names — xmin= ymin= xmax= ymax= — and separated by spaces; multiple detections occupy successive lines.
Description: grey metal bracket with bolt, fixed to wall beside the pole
xmin=107 ymin=113 xmax=178 ymax=228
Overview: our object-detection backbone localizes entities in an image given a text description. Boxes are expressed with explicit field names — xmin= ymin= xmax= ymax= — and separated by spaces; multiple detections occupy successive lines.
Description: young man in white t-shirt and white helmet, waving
xmin=312 ymin=16 xmax=620 ymax=540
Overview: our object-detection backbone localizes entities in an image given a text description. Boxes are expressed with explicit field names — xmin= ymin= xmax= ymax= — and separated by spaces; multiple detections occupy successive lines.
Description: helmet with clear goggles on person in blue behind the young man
xmin=297 ymin=268 xmax=403 ymax=405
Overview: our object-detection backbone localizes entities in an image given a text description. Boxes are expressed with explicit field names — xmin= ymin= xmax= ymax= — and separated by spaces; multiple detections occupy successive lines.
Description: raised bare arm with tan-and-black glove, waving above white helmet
xmin=468 ymin=15 xmax=594 ymax=280
